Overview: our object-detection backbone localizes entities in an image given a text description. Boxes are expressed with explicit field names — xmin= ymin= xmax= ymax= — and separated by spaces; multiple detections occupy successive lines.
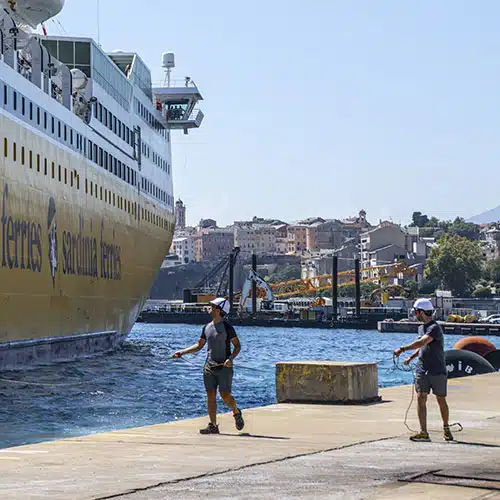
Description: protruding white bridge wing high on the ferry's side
xmin=153 ymin=77 xmax=204 ymax=134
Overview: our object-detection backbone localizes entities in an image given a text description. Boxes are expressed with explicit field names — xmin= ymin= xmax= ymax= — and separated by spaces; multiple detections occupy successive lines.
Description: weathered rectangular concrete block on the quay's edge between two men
xmin=276 ymin=361 xmax=381 ymax=404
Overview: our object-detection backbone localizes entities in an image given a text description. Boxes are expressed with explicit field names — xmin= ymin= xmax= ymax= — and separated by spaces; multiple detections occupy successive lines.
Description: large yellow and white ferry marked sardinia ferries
xmin=0 ymin=0 xmax=203 ymax=369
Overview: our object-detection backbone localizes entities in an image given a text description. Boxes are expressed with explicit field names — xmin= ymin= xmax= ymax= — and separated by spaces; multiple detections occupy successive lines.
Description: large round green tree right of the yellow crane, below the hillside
xmin=425 ymin=234 xmax=482 ymax=297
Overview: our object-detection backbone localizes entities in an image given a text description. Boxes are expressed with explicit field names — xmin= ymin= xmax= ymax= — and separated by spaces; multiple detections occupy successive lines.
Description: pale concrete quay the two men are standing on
xmin=0 ymin=373 xmax=500 ymax=500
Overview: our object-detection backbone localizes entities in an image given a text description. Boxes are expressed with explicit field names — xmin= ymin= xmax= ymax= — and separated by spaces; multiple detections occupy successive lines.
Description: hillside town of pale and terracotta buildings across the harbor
xmin=163 ymin=200 xmax=500 ymax=297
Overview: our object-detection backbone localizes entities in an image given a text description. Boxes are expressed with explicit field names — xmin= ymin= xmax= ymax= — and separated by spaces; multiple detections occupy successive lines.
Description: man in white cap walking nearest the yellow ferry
xmin=172 ymin=298 xmax=245 ymax=434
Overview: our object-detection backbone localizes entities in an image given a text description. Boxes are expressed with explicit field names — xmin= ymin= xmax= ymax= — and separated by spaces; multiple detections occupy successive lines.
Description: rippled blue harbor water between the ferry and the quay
xmin=0 ymin=323 xmax=499 ymax=448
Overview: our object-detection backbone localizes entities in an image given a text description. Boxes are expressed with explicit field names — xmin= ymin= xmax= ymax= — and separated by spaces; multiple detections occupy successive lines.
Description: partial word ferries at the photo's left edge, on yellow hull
xmin=1 ymin=184 xmax=42 ymax=272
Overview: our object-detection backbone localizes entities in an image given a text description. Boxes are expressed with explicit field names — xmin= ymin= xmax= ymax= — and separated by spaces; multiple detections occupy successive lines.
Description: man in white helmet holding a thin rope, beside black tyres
xmin=394 ymin=299 xmax=453 ymax=441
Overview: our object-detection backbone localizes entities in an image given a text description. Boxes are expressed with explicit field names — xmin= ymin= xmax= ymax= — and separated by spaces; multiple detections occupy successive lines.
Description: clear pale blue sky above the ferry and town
xmin=51 ymin=0 xmax=500 ymax=225
